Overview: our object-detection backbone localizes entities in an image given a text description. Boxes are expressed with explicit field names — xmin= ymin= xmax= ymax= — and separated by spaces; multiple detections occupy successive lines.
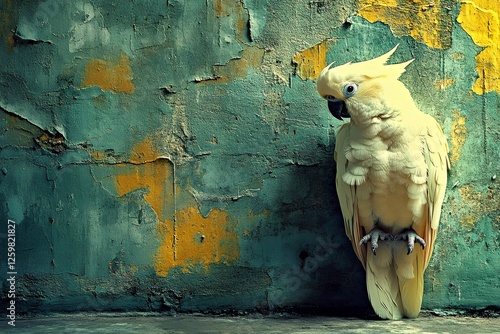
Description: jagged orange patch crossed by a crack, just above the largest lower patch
xmin=115 ymin=139 xmax=174 ymax=221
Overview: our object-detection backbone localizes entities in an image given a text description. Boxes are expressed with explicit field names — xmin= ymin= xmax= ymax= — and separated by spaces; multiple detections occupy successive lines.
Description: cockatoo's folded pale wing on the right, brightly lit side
xmin=422 ymin=115 xmax=450 ymax=270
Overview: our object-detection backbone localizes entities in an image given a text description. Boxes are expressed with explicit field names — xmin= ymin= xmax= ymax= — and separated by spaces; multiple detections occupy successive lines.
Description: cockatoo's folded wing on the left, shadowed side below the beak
xmin=334 ymin=123 xmax=366 ymax=269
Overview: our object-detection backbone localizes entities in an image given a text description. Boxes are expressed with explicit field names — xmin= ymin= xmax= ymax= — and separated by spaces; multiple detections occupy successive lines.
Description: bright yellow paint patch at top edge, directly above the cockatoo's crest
xmin=358 ymin=0 xmax=453 ymax=49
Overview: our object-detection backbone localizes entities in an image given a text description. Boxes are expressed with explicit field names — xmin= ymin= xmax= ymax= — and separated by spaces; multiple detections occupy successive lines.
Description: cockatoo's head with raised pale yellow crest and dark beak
xmin=316 ymin=44 xmax=413 ymax=122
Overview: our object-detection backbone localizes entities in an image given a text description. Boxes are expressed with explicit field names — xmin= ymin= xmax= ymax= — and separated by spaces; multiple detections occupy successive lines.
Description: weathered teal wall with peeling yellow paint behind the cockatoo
xmin=0 ymin=0 xmax=500 ymax=312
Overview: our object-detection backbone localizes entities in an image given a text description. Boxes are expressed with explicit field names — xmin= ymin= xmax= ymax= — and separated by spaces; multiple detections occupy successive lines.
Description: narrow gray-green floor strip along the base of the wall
xmin=0 ymin=314 xmax=500 ymax=334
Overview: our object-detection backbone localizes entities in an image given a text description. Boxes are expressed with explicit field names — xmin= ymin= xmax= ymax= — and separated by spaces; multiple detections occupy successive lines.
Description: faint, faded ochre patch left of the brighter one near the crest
xmin=211 ymin=47 xmax=264 ymax=83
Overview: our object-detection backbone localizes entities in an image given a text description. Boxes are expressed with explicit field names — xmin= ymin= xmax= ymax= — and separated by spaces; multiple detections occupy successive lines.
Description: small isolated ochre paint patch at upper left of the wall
xmin=82 ymin=52 xmax=134 ymax=94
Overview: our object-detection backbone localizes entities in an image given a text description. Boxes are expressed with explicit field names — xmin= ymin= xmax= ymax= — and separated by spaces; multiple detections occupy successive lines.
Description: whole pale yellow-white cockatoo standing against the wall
xmin=317 ymin=45 xmax=449 ymax=319
